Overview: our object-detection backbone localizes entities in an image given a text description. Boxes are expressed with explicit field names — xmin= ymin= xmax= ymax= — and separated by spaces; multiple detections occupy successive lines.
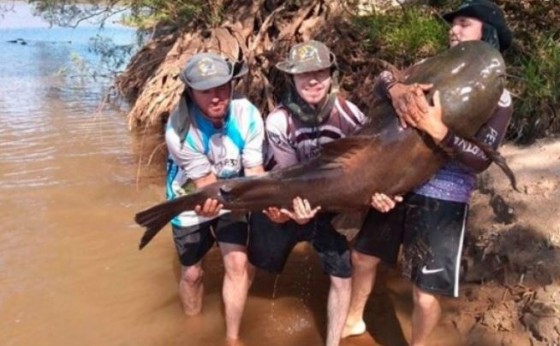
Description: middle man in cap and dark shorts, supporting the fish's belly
xmin=248 ymin=40 xmax=365 ymax=346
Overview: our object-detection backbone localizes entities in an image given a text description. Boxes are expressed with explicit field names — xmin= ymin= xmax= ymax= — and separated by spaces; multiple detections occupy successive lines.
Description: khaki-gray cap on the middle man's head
xmin=276 ymin=40 xmax=336 ymax=74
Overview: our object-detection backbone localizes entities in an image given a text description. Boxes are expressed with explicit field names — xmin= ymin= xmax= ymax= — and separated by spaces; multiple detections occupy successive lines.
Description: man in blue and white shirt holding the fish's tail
xmin=165 ymin=53 xmax=264 ymax=340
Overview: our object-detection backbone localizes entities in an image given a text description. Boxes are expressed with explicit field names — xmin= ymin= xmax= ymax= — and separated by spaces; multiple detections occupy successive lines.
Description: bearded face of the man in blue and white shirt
xmin=191 ymin=83 xmax=231 ymax=125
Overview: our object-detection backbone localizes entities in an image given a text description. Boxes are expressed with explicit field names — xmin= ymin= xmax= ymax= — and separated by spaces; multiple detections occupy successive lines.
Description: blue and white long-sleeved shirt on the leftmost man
xmin=165 ymin=98 xmax=264 ymax=227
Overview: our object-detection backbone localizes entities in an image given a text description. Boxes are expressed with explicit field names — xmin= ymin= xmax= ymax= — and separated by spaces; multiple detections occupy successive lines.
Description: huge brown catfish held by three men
xmin=135 ymin=41 xmax=515 ymax=249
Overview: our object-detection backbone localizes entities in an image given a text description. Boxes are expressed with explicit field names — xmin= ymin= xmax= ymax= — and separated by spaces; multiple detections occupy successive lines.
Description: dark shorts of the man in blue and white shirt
xmin=172 ymin=213 xmax=249 ymax=267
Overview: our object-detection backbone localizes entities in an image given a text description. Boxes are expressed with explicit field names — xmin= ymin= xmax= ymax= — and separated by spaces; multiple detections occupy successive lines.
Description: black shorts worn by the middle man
xmin=247 ymin=212 xmax=352 ymax=278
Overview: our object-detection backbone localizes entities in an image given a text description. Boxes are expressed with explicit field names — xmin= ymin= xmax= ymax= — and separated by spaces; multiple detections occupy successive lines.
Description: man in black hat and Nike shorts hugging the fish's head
xmin=344 ymin=0 xmax=513 ymax=346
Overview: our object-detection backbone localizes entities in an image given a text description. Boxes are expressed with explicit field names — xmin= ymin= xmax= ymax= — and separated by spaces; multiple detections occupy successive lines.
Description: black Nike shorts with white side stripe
xmin=353 ymin=193 xmax=468 ymax=297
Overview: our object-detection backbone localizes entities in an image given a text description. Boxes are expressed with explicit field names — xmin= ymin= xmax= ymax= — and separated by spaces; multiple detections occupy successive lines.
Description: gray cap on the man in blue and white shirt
xmin=179 ymin=53 xmax=247 ymax=90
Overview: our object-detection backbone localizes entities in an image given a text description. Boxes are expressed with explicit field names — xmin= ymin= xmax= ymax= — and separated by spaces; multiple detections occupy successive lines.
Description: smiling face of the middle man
xmin=293 ymin=68 xmax=332 ymax=106
